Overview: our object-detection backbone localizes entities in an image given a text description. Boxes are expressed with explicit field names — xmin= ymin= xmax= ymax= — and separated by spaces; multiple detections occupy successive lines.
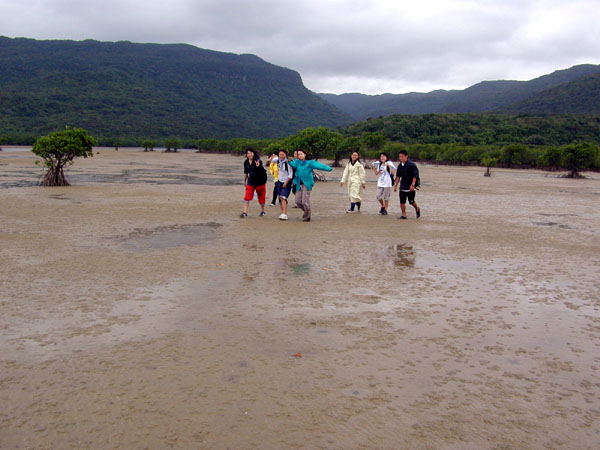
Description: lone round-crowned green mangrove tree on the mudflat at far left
xmin=31 ymin=128 xmax=96 ymax=186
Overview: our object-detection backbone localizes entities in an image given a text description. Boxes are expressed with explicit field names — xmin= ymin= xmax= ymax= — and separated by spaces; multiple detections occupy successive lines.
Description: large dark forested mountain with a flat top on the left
xmin=0 ymin=37 xmax=352 ymax=142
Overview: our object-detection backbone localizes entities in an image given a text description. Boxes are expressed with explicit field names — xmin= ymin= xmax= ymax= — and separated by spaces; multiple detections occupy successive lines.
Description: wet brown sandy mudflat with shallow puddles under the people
xmin=0 ymin=150 xmax=600 ymax=449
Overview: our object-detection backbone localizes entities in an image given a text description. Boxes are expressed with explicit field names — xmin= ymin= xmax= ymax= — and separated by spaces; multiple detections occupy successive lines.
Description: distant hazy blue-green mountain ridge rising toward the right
xmin=319 ymin=64 xmax=600 ymax=120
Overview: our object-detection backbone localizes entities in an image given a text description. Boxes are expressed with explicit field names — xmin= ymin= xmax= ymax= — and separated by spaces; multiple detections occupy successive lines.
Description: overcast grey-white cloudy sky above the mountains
xmin=0 ymin=0 xmax=600 ymax=94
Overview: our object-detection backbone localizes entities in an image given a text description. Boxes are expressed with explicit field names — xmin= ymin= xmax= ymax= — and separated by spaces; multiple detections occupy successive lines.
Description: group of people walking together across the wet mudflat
xmin=240 ymin=149 xmax=421 ymax=222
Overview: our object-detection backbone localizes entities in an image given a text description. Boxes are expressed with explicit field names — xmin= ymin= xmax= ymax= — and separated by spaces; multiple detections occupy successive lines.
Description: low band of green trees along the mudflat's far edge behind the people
xmin=9 ymin=114 xmax=600 ymax=175
